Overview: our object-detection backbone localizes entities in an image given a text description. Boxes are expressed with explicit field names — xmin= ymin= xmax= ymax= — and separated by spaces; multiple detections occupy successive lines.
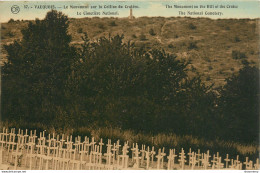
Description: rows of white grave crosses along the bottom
xmin=0 ymin=128 xmax=259 ymax=170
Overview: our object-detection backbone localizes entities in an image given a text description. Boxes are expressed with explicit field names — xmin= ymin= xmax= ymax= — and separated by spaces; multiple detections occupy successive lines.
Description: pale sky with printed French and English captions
xmin=0 ymin=0 xmax=260 ymax=22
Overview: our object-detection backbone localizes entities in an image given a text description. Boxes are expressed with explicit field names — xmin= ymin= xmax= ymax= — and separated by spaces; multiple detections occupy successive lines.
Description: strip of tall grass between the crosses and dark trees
xmin=0 ymin=122 xmax=260 ymax=161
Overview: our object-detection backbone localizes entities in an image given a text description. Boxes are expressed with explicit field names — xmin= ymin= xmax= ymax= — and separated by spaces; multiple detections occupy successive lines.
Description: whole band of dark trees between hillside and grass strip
xmin=1 ymin=11 xmax=259 ymax=159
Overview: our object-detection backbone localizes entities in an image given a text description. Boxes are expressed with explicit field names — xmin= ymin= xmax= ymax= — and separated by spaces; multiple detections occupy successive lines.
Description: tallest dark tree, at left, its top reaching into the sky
xmin=2 ymin=10 xmax=77 ymax=122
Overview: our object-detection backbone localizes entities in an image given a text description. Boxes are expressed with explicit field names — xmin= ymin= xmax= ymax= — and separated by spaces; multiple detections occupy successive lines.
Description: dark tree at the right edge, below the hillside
xmin=219 ymin=65 xmax=259 ymax=142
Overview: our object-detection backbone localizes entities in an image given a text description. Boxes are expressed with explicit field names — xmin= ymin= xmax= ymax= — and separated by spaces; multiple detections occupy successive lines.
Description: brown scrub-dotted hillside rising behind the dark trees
xmin=1 ymin=17 xmax=259 ymax=87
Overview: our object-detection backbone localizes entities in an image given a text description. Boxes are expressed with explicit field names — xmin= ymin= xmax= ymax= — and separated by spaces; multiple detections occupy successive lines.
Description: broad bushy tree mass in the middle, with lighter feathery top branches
xmin=71 ymin=32 xmax=215 ymax=135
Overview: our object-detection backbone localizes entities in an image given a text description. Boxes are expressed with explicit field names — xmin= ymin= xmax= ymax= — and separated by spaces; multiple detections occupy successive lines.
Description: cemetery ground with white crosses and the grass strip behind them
xmin=0 ymin=123 xmax=259 ymax=170
